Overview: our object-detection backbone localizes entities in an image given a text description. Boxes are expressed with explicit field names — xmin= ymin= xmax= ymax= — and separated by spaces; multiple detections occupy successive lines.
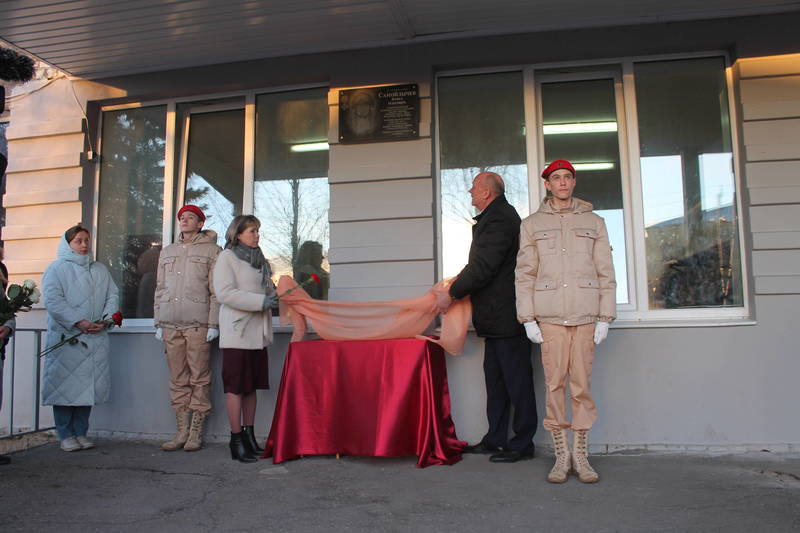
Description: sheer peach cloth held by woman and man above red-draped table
xmin=278 ymin=276 xmax=472 ymax=355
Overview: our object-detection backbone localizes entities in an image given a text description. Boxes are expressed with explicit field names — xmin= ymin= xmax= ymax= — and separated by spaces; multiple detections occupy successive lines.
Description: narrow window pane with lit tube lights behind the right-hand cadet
xmin=541 ymin=78 xmax=629 ymax=303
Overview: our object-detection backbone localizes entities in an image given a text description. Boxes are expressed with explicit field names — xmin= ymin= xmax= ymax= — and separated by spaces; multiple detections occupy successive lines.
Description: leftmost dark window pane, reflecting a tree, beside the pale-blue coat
xmin=97 ymin=106 xmax=166 ymax=318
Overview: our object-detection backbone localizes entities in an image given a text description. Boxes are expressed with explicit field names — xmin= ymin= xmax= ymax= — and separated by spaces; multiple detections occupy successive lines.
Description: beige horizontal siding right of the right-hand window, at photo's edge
xmin=737 ymin=54 xmax=800 ymax=294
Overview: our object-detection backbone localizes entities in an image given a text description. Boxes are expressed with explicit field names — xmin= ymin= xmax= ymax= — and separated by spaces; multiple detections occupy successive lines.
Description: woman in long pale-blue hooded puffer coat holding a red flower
xmin=42 ymin=224 xmax=119 ymax=452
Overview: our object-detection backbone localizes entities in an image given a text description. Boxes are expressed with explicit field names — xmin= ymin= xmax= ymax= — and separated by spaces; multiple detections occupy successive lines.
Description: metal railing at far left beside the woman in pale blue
xmin=0 ymin=328 xmax=55 ymax=439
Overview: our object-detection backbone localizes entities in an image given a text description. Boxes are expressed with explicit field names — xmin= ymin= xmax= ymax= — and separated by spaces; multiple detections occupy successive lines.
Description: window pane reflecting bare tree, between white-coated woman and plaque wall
xmin=254 ymin=89 xmax=330 ymax=299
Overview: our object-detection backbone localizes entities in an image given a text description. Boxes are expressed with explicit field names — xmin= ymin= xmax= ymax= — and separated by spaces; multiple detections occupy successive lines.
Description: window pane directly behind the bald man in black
xmin=439 ymin=72 xmax=529 ymax=277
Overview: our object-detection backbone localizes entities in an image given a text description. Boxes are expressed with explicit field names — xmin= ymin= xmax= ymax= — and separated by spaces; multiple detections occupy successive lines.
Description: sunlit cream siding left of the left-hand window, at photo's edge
xmin=3 ymin=77 xmax=121 ymax=282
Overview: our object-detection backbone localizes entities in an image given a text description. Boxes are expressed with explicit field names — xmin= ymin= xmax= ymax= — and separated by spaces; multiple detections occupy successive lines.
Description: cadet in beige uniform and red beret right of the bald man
xmin=515 ymin=160 xmax=617 ymax=483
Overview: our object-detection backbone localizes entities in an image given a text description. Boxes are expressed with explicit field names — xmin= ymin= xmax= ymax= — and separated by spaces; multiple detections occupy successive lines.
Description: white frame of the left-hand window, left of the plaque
xmin=91 ymin=83 xmax=330 ymax=333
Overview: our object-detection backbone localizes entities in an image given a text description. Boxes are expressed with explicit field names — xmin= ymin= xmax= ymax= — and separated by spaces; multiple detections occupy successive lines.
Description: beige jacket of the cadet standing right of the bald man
xmin=514 ymin=198 xmax=617 ymax=326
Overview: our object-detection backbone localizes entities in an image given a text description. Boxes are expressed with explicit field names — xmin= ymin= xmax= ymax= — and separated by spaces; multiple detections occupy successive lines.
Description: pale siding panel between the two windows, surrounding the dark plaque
xmin=328 ymin=80 xmax=434 ymax=301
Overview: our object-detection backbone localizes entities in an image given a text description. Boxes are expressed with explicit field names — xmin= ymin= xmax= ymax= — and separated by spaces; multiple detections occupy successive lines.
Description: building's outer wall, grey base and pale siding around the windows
xmin=4 ymin=15 xmax=800 ymax=451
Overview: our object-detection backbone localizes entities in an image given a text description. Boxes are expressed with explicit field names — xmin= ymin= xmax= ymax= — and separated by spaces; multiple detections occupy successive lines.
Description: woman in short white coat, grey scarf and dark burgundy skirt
xmin=214 ymin=215 xmax=278 ymax=463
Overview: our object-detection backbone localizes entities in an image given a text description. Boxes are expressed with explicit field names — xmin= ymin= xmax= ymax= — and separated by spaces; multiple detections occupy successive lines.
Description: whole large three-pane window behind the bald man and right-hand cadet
xmin=437 ymin=57 xmax=747 ymax=322
